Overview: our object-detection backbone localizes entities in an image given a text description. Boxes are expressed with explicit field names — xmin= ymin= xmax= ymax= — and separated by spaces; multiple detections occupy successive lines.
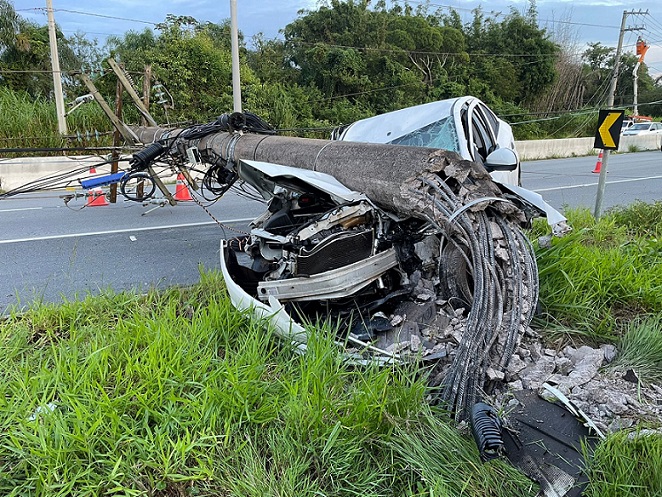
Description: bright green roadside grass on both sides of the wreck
xmin=0 ymin=204 xmax=662 ymax=497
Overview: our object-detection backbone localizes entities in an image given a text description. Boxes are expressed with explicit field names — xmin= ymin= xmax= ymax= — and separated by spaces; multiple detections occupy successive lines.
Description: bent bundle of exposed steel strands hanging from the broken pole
xmin=410 ymin=175 xmax=538 ymax=419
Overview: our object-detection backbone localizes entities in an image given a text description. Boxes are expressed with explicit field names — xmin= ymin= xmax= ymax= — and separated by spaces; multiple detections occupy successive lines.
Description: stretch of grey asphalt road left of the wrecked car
xmin=0 ymin=188 xmax=264 ymax=314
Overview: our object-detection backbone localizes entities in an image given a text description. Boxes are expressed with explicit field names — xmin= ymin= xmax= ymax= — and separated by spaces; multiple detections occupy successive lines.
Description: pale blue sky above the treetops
xmin=10 ymin=0 xmax=662 ymax=76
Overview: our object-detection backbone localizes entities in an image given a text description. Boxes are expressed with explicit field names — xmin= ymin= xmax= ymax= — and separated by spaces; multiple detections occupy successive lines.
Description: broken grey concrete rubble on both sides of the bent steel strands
xmin=370 ymin=286 xmax=662 ymax=433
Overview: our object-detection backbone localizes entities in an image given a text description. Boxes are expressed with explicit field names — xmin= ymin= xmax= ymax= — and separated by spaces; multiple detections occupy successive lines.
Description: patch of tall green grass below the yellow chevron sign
xmin=534 ymin=202 xmax=662 ymax=342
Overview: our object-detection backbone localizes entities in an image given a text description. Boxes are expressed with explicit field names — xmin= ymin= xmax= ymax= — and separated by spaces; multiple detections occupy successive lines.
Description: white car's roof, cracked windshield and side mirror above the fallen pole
xmin=331 ymin=96 xmax=521 ymax=186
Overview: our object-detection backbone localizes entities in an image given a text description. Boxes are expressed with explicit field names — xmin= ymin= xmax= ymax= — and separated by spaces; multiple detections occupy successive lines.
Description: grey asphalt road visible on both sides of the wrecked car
xmin=0 ymin=152 xmax=662 ymax=314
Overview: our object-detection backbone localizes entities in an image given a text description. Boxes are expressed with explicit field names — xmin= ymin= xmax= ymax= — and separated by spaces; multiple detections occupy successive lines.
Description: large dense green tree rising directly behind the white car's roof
xmin=284 ymin=0 xmax=468 ymax=113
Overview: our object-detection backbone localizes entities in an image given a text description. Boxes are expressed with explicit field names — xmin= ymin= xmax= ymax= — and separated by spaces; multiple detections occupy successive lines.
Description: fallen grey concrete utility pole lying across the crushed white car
xmin=131 ymin=127 xmax=521 ymax=223
